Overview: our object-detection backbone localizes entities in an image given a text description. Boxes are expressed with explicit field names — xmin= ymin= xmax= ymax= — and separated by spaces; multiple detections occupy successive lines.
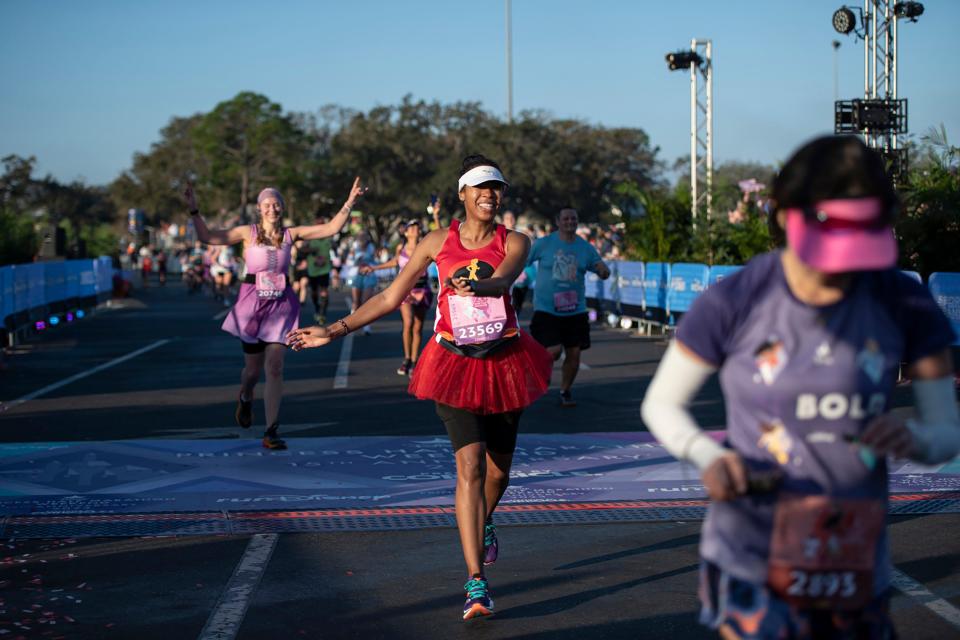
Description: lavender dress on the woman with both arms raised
xmin=220 ymin=225 xmax=300 ymax=344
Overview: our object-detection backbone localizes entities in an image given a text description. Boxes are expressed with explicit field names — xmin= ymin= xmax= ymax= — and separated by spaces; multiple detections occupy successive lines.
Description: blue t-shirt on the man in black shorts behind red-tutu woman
xmin=527 ymin=232 xmax=600 ymax=316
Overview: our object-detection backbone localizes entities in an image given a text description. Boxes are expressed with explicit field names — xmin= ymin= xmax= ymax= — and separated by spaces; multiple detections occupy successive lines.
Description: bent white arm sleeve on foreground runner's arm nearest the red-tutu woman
xmin=640 ymin=341 xmax=727 ymax=471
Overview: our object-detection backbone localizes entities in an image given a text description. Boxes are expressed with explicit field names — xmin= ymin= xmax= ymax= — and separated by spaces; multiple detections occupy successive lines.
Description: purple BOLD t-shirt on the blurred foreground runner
xmin=677 ymin=252 xmax=953 ymax=593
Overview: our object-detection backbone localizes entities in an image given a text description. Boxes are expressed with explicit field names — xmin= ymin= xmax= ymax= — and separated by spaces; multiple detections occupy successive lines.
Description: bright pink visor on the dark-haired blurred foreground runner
xmin=786 ymin=198 xmax=897 ymax=273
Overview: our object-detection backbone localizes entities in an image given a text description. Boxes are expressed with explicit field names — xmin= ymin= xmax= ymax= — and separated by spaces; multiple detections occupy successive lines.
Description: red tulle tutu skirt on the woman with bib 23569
xmin=408 ymin=333 xmax=553 ymax=414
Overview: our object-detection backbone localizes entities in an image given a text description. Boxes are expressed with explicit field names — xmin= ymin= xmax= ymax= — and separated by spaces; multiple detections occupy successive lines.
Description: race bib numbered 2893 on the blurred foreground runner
xmin=767 ymin=494 xmax=886 ymax=609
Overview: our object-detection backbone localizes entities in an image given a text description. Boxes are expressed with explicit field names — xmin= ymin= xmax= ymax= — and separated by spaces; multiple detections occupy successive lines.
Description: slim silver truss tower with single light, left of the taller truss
xmin=690 ymin=38 xmax=713 ymax=225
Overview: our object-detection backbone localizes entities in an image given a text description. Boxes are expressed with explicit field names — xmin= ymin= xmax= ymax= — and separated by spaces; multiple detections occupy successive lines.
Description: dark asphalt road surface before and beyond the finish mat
xmin=0 ymin=284 xmax=960 ymax=640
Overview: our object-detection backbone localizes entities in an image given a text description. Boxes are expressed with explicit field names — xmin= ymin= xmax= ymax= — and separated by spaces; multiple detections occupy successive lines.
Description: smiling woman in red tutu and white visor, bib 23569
xmin=288 ymin=155 xmax=553 ymax=620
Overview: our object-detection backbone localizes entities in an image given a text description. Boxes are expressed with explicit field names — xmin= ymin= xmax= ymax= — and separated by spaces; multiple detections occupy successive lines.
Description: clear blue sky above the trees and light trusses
xmin=0 ymin=0 xmax=960 ymax=184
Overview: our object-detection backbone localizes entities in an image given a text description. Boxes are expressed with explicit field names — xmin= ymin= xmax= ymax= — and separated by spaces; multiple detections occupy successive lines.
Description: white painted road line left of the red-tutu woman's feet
xmin=198 ymin=533 xmax=278 ymax=640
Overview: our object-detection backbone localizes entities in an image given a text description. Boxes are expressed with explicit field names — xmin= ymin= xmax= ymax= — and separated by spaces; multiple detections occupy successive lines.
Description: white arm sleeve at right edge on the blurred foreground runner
xmin=907 ymin=376 xmax=960 ymax=464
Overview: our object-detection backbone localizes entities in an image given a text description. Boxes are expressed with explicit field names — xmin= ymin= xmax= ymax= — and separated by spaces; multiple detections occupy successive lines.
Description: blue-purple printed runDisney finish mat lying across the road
xmin=0 ymin=432 xmax=960 ymax=515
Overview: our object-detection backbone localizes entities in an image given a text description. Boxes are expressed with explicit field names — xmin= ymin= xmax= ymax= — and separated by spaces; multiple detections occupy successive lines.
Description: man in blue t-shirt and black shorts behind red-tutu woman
xmin=527 ymin=208 xmax=610 ymax=407
